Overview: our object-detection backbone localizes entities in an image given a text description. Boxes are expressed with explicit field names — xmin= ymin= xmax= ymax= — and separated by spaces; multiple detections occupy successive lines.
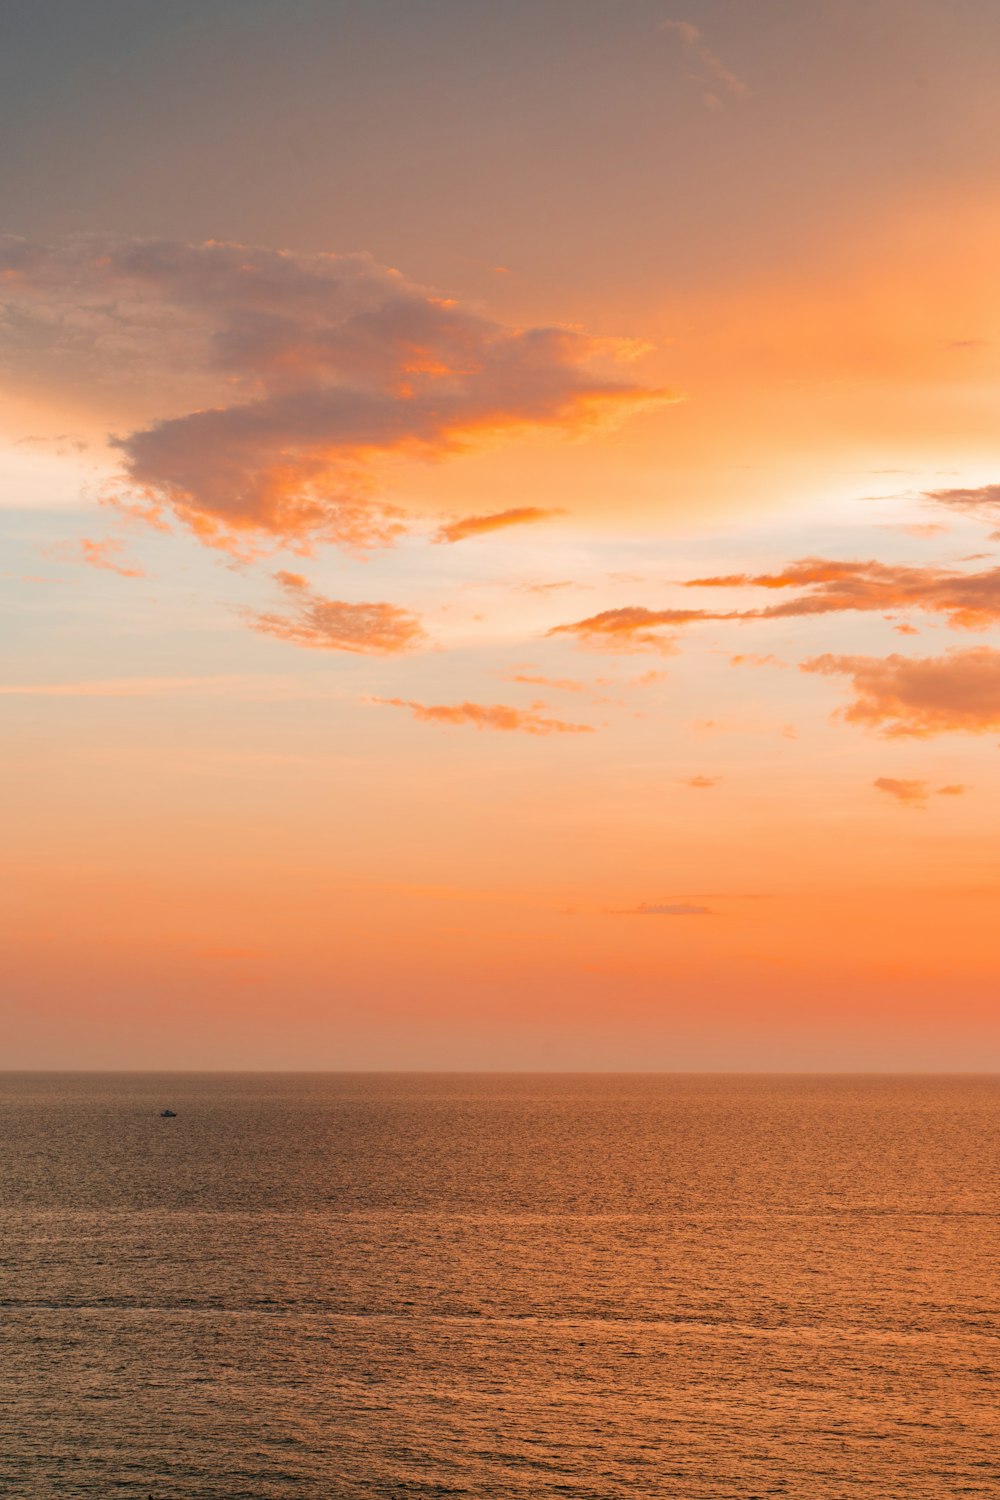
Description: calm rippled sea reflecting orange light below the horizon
xmin=0 ymin=1074 xmax=1000 ymax=1500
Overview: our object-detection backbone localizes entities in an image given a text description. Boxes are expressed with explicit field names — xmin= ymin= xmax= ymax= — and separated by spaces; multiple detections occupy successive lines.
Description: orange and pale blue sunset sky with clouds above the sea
xmin=0 ymin=0 xmax=1000 ymax=1071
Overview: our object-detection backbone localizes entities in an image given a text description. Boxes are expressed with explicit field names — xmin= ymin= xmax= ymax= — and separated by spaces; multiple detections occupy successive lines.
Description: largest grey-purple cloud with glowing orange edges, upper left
xmin=0 ymin=236 xmax=667 ymax=551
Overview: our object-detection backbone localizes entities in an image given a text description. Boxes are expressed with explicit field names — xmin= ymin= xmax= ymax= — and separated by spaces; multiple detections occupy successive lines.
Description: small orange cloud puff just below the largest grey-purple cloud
xmin=249 ymin=572 xmax=426 ymax=656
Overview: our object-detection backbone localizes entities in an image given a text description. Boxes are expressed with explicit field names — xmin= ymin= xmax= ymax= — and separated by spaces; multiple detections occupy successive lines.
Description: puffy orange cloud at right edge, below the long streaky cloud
xmin=802 ymin=647 xmax=1000 ymax=738
